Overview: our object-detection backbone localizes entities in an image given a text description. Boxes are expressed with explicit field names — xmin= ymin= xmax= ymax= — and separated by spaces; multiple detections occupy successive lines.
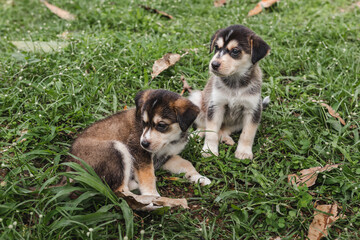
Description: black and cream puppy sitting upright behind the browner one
xmin=189 ymin=25 xmax=270 ymax=159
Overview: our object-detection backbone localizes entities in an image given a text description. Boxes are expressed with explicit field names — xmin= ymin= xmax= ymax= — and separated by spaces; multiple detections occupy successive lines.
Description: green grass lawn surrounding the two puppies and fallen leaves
xmin=0 ymin=0 xmax=360 ymax=239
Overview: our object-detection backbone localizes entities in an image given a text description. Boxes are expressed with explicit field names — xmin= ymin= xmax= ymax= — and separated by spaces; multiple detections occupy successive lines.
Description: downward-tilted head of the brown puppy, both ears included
xmin=135 ymin=90 xmax=199 ymax=153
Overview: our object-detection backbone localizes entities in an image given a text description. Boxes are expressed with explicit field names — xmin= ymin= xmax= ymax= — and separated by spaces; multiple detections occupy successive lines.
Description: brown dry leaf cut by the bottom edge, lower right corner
xmin=308 ymin=203 xmax=340 ymax=240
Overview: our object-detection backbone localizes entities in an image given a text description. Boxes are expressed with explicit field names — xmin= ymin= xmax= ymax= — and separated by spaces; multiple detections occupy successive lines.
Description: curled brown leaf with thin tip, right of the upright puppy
xmin=288 ymin=163 xmax=341 ymax=187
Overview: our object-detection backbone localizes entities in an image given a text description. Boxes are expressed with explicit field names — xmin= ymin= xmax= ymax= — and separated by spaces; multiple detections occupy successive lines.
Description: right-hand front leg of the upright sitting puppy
xmin=235 ymin=114 xmax=259 ymax=159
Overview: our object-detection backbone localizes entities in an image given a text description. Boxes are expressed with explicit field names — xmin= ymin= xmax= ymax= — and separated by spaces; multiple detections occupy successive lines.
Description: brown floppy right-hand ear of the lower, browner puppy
xmin=174 ymin=97 xmax=200 ymax=132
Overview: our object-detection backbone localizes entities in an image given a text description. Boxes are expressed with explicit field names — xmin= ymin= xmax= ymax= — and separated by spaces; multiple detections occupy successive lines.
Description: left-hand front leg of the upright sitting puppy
xmin=203 ymin=103 xmax=225 ymax=157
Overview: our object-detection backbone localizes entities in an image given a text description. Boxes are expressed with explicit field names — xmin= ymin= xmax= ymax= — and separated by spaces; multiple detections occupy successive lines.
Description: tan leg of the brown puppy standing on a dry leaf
xmin=134 ymin=161 xmax=160 ymax=196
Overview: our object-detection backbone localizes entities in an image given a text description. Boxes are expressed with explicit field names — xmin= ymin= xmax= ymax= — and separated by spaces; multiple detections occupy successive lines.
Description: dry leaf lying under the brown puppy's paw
xmin=115 ymin=192 xmax=189 ymax=211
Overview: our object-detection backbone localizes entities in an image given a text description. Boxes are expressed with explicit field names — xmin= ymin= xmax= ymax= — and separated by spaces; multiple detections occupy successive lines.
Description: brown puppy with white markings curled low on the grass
xmin=69 ymin=90 xmax=211 ymax=196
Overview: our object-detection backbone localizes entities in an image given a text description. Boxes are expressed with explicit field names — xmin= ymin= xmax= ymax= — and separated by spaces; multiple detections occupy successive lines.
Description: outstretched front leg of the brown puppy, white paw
xmin=162 ymin=155 xmax=211 ymax=186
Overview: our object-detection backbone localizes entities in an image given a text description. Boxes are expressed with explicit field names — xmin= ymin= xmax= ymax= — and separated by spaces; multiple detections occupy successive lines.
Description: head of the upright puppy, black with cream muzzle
xmin=209 ymin=25 xmax=270 ymax=77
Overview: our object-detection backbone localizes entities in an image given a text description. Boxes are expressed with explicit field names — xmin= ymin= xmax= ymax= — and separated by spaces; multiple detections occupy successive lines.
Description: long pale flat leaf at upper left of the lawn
xmin=11 ymin=41 xmax=69 ymax=53
